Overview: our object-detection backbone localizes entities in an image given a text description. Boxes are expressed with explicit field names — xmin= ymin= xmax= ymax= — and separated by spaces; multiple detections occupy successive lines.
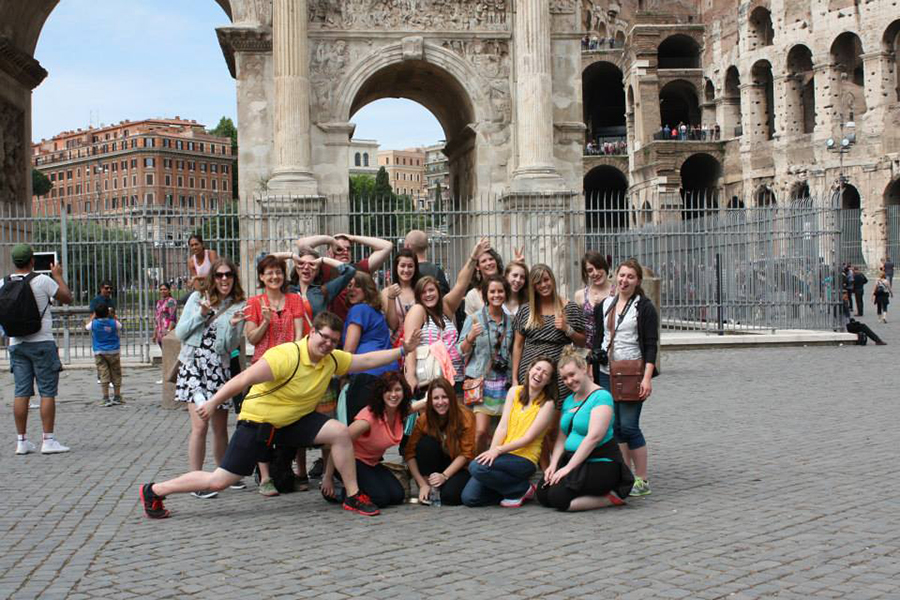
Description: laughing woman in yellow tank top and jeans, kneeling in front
xmin=462 ymin=356 xmax=556 ymax=508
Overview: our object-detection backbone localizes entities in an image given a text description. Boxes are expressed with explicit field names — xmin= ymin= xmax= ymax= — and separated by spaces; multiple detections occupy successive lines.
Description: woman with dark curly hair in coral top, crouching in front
xmin=322 ymin=371 xmax=412 ymax=508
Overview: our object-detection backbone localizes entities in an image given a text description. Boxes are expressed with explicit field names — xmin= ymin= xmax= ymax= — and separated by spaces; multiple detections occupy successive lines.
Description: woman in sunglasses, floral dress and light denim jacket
xmin=175 ymin=258 xmax=244 ymax=498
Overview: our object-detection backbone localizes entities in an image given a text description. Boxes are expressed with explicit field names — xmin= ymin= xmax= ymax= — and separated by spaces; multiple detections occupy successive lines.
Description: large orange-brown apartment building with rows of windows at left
xmin=32 ymin=117 xmax=236 ymax=240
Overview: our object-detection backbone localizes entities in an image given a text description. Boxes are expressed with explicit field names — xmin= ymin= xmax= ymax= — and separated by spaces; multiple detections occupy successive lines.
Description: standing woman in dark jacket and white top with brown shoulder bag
xmin=594 ymin=258 xmax=659 ymax=496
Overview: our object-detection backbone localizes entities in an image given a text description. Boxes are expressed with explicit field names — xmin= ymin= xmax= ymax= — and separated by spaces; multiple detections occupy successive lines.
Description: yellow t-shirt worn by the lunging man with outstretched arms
xmin=238 ymin=337 xmax=353 ymax=427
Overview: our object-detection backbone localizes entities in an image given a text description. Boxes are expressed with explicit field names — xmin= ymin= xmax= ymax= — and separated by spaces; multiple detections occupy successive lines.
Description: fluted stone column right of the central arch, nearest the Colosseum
xmin=512 ymin=0 xmax=566 ymax=192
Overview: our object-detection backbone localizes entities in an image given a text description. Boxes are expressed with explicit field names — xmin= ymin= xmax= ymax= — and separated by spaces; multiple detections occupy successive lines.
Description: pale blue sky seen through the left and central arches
xmin=32 ymin=0 xmax=444 ymax=149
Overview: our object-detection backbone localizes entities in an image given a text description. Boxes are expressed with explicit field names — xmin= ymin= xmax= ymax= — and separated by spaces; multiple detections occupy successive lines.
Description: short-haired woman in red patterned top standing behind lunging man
xmin=244 ymin=254 xmax=312 ymax=496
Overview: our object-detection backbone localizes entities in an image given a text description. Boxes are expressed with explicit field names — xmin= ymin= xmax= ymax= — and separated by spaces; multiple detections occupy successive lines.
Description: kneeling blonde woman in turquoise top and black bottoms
xmin=537 ymin=346 xmax=634 ymax=511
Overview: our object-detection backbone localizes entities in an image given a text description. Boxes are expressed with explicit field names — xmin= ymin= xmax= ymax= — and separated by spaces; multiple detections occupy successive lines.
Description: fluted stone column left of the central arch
xmin=269 ymin=0 xmax=317 ymax=196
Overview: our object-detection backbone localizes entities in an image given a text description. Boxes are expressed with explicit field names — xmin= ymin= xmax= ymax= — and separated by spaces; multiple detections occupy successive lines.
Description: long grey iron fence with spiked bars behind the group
xmin=0 ymin=192 xmax=848 ymax=362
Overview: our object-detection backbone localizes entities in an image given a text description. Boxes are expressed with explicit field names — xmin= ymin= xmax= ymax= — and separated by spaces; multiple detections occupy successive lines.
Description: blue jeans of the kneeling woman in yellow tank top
xmin=462 ymin=454 xmax=536 ymax=506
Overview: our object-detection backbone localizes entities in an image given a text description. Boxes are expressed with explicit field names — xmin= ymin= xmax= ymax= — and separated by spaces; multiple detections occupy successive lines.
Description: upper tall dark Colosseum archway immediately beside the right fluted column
xmin=581 ymin=61 xmax=626 ymax=139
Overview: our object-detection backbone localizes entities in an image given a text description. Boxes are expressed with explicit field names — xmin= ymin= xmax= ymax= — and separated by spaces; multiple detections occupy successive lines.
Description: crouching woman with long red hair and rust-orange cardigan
xmin=404 ymin=377 xmax=475 ymax=506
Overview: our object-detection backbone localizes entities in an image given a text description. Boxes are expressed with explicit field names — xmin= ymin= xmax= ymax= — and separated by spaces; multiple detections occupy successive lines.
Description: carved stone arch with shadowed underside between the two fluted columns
xmin=336 ymin=38 xmax=496 ymax=197
